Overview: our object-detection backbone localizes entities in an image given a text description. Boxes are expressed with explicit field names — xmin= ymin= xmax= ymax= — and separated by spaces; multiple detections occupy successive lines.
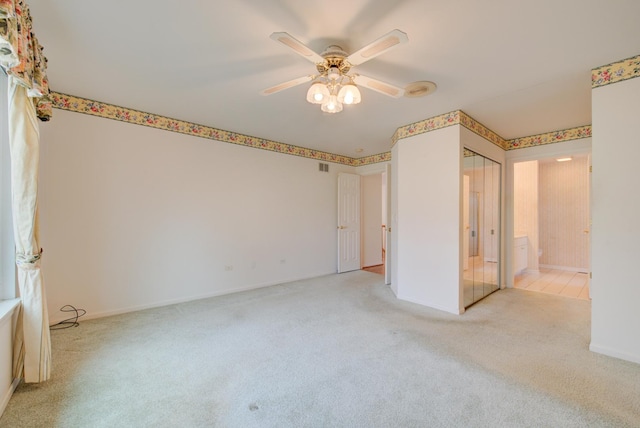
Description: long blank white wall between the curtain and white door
xmin=40 ymin=110 xmax=354 ymax=320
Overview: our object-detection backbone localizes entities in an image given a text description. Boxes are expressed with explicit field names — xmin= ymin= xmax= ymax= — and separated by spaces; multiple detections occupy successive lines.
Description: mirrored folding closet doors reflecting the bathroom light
xmin=462 ymin=149 xmax=501 ymax=307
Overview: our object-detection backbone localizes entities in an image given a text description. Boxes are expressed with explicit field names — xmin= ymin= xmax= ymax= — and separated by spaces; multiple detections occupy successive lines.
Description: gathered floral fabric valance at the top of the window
xmin=0 ymin=0 xmax=52 ymax=121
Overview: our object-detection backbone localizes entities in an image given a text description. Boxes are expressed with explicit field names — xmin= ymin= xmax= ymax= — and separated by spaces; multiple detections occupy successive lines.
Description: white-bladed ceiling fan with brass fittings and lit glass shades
xmin=260 ymin=30 xmax=409 ymax=113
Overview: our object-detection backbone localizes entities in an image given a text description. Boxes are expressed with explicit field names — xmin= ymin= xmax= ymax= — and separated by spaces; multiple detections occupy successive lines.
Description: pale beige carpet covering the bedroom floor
xmin=0 ymin=271 xmax=640 ymax=427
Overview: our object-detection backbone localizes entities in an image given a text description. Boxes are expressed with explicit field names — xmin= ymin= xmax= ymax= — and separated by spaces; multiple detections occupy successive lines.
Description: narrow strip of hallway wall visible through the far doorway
xmin=360 ymin=174 xmax=383 ymax=267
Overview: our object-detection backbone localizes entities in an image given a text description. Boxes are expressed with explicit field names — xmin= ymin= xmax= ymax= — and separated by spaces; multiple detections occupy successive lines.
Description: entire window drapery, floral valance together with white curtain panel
xmin=0 ymin=0 xmax=51 ymax=382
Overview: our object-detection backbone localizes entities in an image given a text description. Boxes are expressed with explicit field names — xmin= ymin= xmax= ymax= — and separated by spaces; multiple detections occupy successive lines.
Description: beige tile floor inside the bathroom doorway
xmin=514 ymin=268 xmax=589 ymax=300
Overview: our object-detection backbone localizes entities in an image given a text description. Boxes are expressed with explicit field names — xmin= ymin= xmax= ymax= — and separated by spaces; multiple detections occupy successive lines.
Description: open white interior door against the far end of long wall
xmin=338 ymin=173 xmax=361 ymax=273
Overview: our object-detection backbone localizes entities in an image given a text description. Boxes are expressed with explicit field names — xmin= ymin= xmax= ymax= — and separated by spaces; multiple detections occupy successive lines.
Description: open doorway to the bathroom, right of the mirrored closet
xmin=513 ymin=153 xmax=591 ymax=299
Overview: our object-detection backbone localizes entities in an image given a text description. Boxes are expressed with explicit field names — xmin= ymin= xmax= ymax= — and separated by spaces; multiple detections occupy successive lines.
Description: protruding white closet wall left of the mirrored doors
xmin=391 ymin=125 xmax=464 ymax=314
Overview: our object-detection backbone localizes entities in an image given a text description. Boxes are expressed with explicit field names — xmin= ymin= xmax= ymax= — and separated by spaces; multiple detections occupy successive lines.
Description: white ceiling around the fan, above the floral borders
xmin=27 ymin=0 xmax=640 ymax=157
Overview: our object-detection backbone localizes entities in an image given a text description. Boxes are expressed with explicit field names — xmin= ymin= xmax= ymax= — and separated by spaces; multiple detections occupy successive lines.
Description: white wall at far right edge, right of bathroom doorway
xmin=590 ymin=78 xmax=640 ymax=363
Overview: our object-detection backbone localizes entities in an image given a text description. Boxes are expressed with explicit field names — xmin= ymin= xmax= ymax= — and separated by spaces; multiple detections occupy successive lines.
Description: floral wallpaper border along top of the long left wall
xmin=51 ymin=92 xmax=370 ymax=166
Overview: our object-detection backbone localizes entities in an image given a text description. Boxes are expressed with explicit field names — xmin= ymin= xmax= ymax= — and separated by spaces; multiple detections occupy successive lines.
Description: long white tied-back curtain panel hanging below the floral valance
xmin=9 ymin=76 xmax=51 ymax=382
